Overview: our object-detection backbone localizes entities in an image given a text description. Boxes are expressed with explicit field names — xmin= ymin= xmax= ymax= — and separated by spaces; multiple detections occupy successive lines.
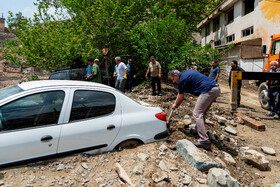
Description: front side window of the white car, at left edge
xmin=0 ymin=91 xmax=65 ymax=131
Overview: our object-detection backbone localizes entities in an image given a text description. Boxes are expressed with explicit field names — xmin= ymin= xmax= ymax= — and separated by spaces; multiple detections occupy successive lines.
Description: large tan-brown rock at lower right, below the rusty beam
xmin=240 ymin=149 xmax=269 ymax=171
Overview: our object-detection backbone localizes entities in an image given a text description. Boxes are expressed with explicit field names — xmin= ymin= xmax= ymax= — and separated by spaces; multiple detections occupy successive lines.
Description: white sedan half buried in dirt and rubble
xmin=0 ymin=80 xmax=168 ymax=166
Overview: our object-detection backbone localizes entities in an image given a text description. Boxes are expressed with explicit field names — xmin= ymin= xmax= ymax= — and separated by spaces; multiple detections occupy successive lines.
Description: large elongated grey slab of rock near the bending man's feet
xmin=176 ymin=139 xmax=219 ymax=171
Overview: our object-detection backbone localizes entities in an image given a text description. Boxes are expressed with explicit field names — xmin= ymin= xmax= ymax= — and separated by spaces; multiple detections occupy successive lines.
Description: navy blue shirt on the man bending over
xmin=178 ymin=69 xmax=217 ymax=95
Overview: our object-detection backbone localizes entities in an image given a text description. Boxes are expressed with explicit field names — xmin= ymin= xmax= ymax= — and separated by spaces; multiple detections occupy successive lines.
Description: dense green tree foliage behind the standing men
xmin=2 ymin=0 xmax=221 ymax=74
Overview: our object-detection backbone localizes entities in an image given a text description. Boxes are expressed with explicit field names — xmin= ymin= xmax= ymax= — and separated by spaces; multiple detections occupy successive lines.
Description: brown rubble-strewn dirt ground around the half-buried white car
xmin=0 ymin=64 xmax=280 ymax=187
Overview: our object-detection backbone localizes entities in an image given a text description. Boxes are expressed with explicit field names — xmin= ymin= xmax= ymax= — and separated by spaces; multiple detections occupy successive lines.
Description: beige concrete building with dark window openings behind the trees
xmin=197 ymin=0 xmax=280 ymax=71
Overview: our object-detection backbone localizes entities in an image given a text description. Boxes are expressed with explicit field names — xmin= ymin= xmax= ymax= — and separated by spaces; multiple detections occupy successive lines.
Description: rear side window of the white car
xmin=70 ymin=90 xmax=116 ymax=122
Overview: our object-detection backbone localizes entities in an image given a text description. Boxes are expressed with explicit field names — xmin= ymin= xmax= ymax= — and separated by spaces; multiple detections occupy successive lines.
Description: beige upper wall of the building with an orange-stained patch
xmin=201 ymin=0 xmax=280 ymax=46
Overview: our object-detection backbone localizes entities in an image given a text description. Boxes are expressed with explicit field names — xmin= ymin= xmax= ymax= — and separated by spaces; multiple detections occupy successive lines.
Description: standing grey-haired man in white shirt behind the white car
xmin=115 ymin=56 xmax=128 ymax=93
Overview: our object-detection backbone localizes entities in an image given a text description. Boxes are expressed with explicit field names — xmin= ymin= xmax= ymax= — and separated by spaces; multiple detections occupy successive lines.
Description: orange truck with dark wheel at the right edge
xmin=257 ymin=33 xmax=280 ymax=109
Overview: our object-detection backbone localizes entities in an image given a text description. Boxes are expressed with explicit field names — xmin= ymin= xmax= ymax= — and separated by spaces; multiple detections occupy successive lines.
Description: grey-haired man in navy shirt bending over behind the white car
xmin=168 ymin=69 xmax=220 ymax=150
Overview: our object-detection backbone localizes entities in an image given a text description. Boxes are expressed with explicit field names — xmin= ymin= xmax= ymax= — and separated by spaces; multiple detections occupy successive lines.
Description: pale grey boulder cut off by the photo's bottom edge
xmin=207 ymin=168 xmax=241 ymax=187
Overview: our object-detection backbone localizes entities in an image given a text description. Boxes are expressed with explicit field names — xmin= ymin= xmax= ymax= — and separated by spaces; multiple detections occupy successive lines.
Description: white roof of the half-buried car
xmin=18 ymin=80 xmax=113 ymax=90
